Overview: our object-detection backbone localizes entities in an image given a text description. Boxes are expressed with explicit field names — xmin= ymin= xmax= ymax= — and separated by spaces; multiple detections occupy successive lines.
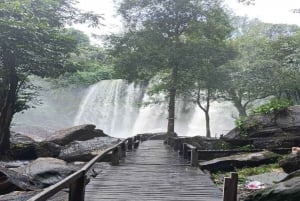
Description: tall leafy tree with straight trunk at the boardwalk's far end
xmin=111 ymin=0 xmax=230 ymax=134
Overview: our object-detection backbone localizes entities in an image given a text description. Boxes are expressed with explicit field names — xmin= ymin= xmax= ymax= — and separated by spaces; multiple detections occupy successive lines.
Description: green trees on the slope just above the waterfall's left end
xmin=51 ymin=29 xmax=114 ymax=87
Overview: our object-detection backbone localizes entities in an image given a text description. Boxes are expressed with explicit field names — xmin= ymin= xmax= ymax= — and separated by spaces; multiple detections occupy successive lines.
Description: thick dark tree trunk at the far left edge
xmin=0 ymin=50 xmax=18 ymax=156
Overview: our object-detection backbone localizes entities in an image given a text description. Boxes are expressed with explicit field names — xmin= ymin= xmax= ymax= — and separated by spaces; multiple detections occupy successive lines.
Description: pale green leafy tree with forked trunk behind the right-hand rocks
xmin=223 ymin=19 xmax=298 ymax=117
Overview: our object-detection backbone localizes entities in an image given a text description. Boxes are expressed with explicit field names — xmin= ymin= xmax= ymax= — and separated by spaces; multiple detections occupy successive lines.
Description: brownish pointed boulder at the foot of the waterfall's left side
xmin=48 ymin=124 xmax=107 ymax=145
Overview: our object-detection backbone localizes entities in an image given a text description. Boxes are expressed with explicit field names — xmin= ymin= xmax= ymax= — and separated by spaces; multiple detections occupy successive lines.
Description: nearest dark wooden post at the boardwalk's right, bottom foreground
xmin=223 ymin=172 xmax=238 ymax=201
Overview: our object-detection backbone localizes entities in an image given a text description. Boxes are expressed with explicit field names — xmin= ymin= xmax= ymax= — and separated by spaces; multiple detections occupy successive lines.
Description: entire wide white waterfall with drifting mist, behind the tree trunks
xmin=12 ymin=80 xmax=236 ymax=138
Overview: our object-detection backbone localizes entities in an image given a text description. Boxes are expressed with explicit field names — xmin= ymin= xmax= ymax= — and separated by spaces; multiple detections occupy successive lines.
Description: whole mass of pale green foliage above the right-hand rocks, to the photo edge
xmin=223 ymin=19 xmax=300 ymax=116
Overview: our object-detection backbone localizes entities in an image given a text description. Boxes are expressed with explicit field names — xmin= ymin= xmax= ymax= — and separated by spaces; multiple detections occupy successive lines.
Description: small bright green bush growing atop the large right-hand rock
xmin=251 ymin=98 xmax=292 ymax=114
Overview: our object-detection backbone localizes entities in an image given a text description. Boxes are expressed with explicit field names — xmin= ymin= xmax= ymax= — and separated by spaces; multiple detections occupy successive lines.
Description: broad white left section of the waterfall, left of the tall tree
xmin=74 ymin=80 xmax=143 ymax=137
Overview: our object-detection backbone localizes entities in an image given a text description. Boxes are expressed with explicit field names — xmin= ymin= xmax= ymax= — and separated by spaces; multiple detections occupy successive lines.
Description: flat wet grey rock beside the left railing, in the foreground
xmin=16 ymin=158 xmax=79 ymax=187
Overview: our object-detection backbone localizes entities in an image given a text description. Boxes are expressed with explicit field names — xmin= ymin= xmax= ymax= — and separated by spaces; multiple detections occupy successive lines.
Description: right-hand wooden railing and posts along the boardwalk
xmin=166 ymin=137 xmax=238 ymax=201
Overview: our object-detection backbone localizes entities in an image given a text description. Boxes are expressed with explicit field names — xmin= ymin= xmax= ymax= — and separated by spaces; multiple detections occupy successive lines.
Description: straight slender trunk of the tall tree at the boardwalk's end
xmin=167 ymin=67 xmax=178 ymax=135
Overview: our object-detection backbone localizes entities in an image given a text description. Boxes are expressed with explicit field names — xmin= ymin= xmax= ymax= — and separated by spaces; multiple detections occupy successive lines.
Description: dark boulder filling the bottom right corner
xmin=244 ymin=172 xmax=300 ymax=201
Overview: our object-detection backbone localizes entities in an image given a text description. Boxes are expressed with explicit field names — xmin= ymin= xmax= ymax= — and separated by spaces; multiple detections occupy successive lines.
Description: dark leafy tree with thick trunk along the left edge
xmin=0 ymin=0 xmax=101 ymax=155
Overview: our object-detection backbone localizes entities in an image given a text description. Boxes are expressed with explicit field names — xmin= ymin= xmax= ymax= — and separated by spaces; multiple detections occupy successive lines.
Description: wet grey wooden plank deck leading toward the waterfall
xmin=85 ymin=140 xmax=222 ymax=201
